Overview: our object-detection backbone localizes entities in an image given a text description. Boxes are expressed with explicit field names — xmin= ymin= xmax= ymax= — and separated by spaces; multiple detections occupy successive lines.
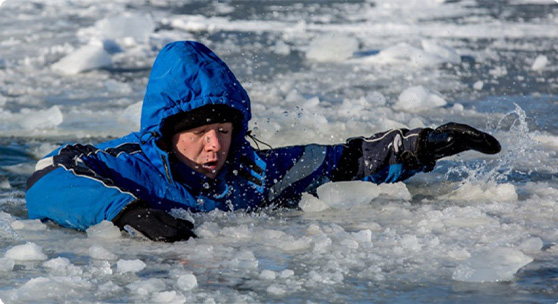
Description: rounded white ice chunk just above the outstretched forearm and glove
xmin=393 ymin=86 xmax=447 ymax=112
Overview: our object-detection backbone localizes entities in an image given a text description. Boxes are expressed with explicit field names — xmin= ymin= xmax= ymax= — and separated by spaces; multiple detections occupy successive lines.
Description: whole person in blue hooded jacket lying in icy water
xmin=26 ymin=41 xmax=500 ymax=242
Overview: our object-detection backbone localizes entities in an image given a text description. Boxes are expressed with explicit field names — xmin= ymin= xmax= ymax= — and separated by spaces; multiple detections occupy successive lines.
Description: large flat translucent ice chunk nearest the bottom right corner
xmin=452 ymin=247 xmax=533 ymax=282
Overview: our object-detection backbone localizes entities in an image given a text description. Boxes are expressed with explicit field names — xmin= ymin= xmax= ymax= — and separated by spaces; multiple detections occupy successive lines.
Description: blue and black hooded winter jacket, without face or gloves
xmin=26 ymin=41 xmax=428 ymax=229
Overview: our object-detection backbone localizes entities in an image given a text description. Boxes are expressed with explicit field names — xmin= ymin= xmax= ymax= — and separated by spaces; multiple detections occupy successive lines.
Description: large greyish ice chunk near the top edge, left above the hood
xmin=95 ymin=12 xmax=155 ymax=42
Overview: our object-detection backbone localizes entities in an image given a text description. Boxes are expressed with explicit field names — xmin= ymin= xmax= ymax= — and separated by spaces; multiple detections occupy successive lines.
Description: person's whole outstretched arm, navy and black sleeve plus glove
xmin=260 ymin=123 xmax=501 ymax=204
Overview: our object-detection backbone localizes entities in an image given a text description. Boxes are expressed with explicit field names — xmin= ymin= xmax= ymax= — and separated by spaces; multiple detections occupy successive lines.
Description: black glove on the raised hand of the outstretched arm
xmin=415 ymin=122 xmax=502 ymax=169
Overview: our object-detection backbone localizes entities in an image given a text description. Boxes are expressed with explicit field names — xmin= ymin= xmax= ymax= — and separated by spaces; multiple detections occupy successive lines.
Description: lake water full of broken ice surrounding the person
xmin=0 ymin=0 xmax=558 ymax=303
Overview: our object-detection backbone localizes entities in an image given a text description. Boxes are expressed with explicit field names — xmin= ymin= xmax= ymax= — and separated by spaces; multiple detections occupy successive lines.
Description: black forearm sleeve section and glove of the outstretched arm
xmin=331 ymin=122 xmax=501 ymax=181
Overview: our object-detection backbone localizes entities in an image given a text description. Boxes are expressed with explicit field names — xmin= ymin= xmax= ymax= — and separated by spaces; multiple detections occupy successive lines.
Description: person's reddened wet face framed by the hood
xmin=172 ymin=122 xmax=233 ymax=178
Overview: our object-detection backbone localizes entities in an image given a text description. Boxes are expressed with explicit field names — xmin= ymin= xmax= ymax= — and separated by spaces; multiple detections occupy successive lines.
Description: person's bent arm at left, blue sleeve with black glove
xmin=26 ymin=144 xmax=195 ymax=242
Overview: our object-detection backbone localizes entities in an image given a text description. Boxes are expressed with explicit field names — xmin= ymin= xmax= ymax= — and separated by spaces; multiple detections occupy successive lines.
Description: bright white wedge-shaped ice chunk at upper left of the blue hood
xmin=52 ymin=45 xmax=112 ymax=75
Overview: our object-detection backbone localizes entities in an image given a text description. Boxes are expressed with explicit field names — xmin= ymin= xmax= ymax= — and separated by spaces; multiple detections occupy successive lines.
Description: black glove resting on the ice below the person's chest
xmin=112 ymin=200 xmax=196 ymax=242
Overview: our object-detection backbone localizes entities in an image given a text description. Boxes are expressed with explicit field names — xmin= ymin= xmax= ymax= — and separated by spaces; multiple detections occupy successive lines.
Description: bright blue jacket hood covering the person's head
xmin=140 ymin=41 xmax=251 ymax=137
